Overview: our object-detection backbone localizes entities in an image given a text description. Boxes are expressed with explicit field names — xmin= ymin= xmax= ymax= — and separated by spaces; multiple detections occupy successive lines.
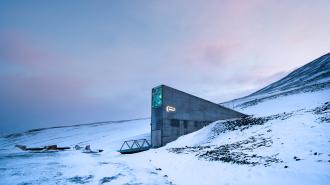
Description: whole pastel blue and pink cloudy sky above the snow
xmin=0 ymin=0 xmax=330 ymax=134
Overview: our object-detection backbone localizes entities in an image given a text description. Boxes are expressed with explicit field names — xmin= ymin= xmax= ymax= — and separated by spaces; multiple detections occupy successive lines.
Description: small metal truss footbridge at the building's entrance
xmin=118 ymin=139 xmax=151 ymax=154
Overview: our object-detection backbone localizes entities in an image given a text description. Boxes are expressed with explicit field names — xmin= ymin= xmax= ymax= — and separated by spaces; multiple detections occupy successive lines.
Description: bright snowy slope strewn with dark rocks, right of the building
xmin=149 ymin=90 xmax=330 ymax=185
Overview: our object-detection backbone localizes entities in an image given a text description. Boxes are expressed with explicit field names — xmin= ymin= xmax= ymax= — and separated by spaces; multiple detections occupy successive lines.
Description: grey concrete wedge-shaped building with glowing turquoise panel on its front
xmin=151 ymin=85 xmax=245 ymax=147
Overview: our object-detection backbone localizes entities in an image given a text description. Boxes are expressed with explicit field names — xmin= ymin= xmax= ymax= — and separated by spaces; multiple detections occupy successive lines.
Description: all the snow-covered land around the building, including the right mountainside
xmin=0 ymin=54 xmax=330 ymax=185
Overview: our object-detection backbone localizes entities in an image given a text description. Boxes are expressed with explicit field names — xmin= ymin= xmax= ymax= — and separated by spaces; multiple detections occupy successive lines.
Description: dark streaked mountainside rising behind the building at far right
xmin=222 ymin=53 xmax=330 ymax=108
